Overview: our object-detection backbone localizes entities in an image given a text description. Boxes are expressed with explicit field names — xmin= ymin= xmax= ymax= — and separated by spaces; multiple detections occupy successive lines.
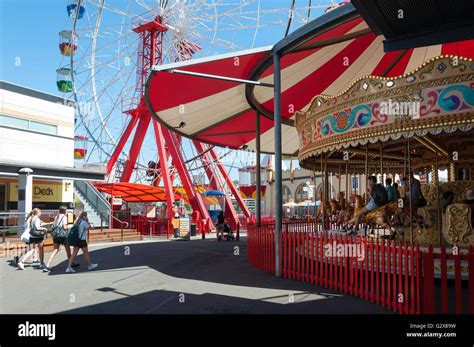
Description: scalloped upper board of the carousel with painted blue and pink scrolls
xmin=296 ymin=57 xmax=474 ymax=147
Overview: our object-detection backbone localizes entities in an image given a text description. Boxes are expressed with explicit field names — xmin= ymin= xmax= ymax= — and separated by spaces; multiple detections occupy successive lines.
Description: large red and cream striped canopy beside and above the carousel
xmin=146 ymin=4 xmax=474 ymax=156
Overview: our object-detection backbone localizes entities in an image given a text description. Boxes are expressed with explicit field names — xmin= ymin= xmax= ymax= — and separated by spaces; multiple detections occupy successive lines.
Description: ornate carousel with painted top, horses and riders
xmin=295 ymin=55 xmax=474 ymax=247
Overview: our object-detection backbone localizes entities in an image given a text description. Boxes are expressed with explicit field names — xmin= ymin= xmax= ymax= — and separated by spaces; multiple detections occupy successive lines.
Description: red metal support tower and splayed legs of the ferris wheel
xmin=103 ymin=17 xmax=241 ymax=230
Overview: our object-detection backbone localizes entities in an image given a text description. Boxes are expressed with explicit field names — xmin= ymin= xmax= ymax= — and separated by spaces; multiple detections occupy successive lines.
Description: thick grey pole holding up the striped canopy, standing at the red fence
xmin=273 ymin=52 xmax=283 ymax=277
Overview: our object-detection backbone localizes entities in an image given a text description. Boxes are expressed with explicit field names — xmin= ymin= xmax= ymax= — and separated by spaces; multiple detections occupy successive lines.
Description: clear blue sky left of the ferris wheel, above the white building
xmin=0 ymin=0 xmax=68 ymax=94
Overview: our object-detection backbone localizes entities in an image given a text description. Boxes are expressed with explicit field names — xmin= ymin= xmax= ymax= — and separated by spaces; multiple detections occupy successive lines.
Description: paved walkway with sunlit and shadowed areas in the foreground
xmin=0 ymin=238 xmax=389 ymax=314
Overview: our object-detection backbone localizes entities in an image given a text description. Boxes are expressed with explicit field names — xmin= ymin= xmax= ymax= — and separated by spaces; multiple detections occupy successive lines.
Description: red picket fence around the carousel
xmin=247 ymin=222 xmax=474 ymax=314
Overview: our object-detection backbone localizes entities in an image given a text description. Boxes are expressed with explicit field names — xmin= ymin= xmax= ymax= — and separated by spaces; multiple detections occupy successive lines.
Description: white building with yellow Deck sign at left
xmin=0 ymin=81 xmax=104 ymax=213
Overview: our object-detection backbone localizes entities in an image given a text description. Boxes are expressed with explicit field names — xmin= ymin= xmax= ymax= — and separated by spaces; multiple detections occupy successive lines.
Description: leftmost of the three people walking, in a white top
xmin=17 ymin=208 xmax=51 ymax=270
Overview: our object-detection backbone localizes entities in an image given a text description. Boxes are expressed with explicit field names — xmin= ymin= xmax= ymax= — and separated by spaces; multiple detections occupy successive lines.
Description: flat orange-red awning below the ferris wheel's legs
xmin=94 ymin=182 xmax=180 ymax=202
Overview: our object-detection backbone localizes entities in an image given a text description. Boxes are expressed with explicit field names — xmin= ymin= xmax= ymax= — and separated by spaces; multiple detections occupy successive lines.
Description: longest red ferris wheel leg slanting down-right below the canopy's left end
xmin=163 ymin=129 xmax=214 ymax=228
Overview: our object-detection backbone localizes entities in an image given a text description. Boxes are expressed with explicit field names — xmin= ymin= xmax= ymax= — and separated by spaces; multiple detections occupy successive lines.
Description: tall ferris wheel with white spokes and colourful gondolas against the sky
xmin=57 ymin=0 xmax=337 ymax=192
